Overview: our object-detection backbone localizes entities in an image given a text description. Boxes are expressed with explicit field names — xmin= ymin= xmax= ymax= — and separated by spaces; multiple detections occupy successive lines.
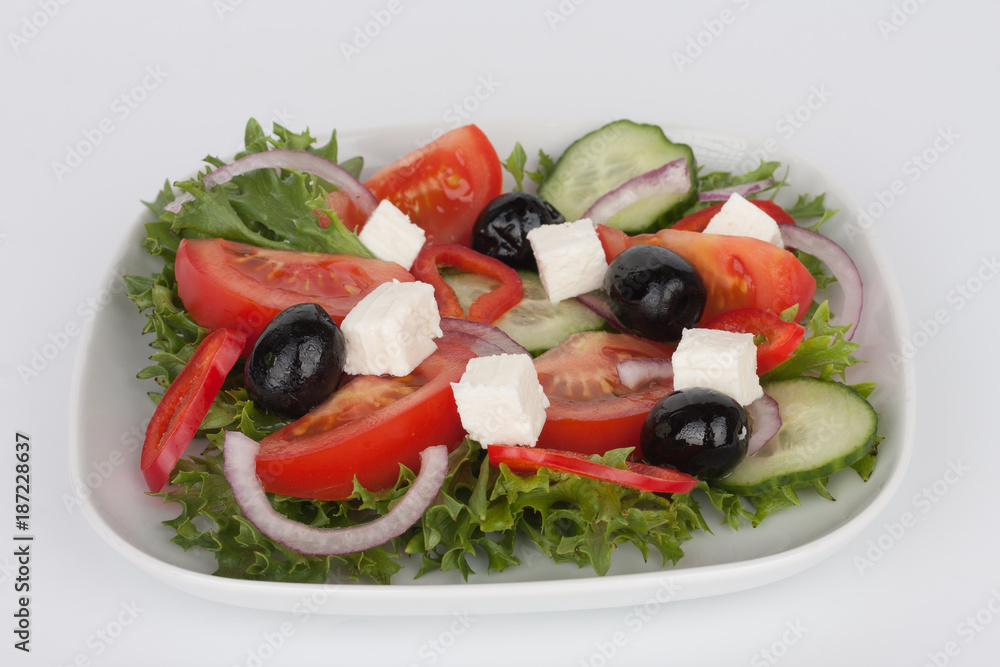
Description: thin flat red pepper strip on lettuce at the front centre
xmin=489 ymin=445 xmax=698 ymax=493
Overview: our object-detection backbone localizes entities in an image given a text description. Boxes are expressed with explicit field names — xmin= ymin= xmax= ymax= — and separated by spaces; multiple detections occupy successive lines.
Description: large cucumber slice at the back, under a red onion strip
xmin=538 ymin=120 xmax=698 ymax=234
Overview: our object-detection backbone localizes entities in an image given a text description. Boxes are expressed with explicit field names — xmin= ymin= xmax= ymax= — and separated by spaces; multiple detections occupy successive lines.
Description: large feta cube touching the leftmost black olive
xmin=340 ymin=280 xmax=443 ymax=376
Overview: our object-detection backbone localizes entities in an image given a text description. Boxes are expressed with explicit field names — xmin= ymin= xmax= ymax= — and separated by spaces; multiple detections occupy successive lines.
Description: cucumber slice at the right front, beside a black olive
xmin=714 ymin=377 xmax=878 ymax=496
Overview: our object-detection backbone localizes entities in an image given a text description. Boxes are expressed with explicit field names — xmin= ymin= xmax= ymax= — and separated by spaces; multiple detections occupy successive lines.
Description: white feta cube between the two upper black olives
xmin=528 ymin=218 xmax=608 ymax=303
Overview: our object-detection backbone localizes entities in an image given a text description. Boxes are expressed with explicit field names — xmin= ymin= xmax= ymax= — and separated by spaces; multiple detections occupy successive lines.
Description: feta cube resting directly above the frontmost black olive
xmin=673 ymin=329 xmax=764 ymax=405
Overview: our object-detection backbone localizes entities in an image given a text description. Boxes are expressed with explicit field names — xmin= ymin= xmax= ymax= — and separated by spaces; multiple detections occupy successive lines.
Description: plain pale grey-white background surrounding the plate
xmin=0 ymin=0 xmax=1000 ymax=666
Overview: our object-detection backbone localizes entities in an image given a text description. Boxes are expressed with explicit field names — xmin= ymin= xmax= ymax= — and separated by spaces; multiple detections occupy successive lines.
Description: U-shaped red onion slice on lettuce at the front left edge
xmin=223 ymin=431 xmax=448 ymax=556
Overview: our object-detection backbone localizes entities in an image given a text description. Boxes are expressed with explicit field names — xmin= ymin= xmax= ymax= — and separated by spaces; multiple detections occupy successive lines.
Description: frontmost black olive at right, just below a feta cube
xmin=639 ymin=388 xmax=750 ymax=480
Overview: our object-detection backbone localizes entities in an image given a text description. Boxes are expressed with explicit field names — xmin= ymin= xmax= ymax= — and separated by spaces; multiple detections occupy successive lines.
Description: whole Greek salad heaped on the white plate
xmin=125 ymin=119 xmax=880 ymax=583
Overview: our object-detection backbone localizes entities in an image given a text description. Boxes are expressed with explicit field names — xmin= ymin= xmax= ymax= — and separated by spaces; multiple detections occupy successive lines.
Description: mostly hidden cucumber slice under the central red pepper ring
xmin=443 ymin=271 xmax=604 ymax=355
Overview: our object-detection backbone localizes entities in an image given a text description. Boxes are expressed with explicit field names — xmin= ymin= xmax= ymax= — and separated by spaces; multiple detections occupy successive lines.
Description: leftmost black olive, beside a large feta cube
xmin=244 ymin=303 xmax=345 ymax=417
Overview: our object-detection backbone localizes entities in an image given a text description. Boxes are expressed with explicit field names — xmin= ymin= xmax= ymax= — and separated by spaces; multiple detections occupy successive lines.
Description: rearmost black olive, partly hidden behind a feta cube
xmin=472 ymin=192 xmax=566 ymax=269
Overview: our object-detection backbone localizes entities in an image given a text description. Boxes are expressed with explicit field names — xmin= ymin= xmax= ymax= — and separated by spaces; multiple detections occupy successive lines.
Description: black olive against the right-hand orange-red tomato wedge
xmin=604 ymin=245 xmax=708 ymax=342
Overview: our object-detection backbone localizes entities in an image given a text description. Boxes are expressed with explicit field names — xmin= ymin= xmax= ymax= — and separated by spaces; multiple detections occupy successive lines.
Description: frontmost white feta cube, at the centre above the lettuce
xmin=451 ymin=354 xmax=549 ymax=447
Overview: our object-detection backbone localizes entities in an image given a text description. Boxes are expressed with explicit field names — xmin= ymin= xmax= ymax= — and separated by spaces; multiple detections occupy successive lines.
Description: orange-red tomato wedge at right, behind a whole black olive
xmin=597 ymin=225 xmax=816 ymax=322
